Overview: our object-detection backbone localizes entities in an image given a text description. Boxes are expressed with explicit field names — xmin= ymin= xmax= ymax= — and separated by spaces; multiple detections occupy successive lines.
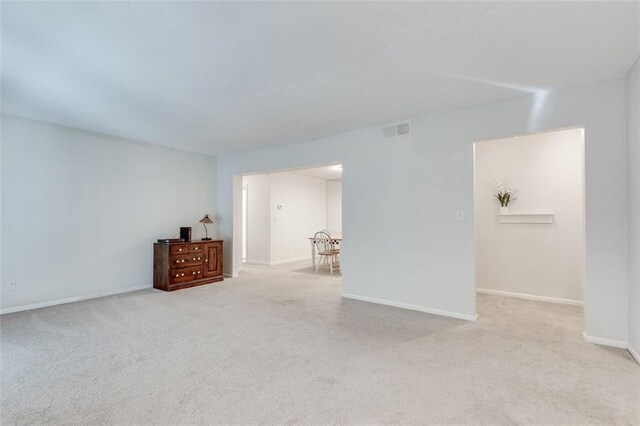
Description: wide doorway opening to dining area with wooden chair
xmin=234 ymin=163 xmax=342 ymax=286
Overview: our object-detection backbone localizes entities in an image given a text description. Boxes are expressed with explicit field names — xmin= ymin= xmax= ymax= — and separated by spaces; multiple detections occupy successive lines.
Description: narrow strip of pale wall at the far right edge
xmin=627 ymin=59 xmax=640 ymax=356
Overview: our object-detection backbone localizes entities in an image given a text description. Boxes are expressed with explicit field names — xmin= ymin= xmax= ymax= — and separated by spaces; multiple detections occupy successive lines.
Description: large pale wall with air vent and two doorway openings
xmin=218 ymin=79 xmax=628 ymax=342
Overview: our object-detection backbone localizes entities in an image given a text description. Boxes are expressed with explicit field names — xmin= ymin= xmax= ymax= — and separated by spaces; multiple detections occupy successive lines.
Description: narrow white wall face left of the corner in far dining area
xmin=243 ymin=175 xmax=271 ymax=263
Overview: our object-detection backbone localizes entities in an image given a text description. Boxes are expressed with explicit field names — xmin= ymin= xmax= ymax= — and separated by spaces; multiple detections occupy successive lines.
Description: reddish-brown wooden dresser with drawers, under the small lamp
xmin=153 ymin=240 xmax=223 ymax=291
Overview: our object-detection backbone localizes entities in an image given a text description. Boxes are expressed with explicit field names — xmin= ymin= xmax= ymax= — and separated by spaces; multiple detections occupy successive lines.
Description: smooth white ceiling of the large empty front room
xmin=2 ymin=1 xmax=640 ymax=154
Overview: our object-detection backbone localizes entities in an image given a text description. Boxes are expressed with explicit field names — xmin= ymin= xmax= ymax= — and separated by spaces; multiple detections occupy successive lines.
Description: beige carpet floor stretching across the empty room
xmin=1 ymin=264 xmax=640 ymax=425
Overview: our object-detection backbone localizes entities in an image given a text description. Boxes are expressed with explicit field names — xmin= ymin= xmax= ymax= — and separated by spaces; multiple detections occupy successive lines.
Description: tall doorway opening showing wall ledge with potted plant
xmin=474 ymin=128 xmax=585 ymax=333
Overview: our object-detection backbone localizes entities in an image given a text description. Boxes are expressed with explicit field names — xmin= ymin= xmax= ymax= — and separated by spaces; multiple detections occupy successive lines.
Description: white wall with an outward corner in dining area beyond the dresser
xmin=243 ymin=172 xmax=327 ymax=265
